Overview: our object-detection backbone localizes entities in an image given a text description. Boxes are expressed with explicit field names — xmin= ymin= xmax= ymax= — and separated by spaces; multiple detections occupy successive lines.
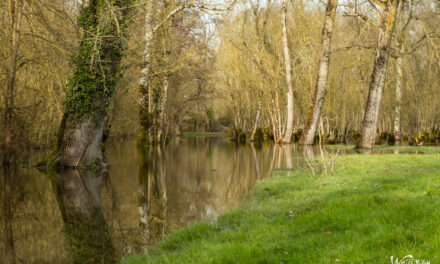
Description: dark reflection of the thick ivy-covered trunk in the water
xmin=47 ymin=170 xmax=118 ymax=264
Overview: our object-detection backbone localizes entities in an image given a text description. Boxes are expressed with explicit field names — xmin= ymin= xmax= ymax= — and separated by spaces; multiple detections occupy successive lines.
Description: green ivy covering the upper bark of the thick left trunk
xmin=64 ymin=0 xmax=130 ymax=121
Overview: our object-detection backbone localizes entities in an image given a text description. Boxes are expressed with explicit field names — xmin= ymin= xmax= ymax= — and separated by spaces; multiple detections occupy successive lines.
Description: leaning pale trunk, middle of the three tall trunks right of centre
xmin=300 ymin=0 xmax=338 ymax=145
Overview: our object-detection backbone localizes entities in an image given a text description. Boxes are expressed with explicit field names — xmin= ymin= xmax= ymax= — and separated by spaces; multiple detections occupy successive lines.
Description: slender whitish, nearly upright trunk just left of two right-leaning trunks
xmin=281 ymin=0 xmax=294 ymax=143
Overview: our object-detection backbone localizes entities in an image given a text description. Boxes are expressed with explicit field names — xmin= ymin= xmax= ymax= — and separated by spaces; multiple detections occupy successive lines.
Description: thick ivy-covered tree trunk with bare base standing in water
xmin=50 ymin=0 xmax=130 ymax=167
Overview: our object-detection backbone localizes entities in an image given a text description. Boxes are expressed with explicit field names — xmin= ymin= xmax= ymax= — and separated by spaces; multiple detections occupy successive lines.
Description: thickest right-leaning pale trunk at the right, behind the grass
xmin=357 ymin=0 xmax=399 ymax=149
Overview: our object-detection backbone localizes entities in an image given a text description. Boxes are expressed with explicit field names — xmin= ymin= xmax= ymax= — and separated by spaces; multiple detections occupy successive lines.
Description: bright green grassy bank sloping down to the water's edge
xmin=122 ymin=154 xmax=440 ymax=264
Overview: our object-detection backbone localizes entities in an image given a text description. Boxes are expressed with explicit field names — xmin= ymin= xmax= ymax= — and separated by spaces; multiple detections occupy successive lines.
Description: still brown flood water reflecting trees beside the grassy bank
xmin=0 ymin=137 xmax=434 ymax=264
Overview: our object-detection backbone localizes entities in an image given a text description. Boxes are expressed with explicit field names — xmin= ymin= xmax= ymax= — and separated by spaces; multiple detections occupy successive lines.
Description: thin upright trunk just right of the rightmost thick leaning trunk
xmin=394 ymin=42 xmax=404 ymax=145
